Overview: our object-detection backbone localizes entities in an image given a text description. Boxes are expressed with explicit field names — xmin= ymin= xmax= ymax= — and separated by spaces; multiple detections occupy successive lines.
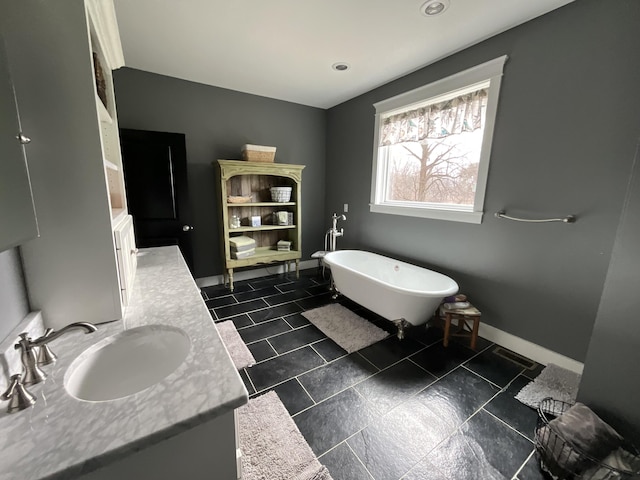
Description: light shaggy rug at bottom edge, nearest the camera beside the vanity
xmin=238 ymin=391 xmax=331 ymax=480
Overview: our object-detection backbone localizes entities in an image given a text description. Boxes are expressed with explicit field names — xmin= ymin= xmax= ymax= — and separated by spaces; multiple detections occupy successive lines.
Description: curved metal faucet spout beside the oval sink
xmin=14 ymin=322 xmax=98 ymax=385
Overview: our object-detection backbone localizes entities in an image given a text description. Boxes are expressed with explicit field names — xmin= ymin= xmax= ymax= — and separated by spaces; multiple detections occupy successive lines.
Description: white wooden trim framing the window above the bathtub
xmin=369 ymin=55 xmax=508 ymax=224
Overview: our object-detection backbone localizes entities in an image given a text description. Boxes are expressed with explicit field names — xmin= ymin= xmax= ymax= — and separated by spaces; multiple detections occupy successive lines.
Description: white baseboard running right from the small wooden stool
xmin=478 ymin=323 xmax=584 ymax=374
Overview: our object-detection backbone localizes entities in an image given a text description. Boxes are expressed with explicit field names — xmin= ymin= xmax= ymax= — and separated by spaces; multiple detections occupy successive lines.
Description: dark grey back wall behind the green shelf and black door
xmin=114 ymin=68 xmax=327 ymax=278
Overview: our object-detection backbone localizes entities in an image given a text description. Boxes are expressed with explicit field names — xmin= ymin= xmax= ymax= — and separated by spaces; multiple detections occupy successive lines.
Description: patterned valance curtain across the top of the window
xmin=380 ymin=88 xmax=488 ymax=146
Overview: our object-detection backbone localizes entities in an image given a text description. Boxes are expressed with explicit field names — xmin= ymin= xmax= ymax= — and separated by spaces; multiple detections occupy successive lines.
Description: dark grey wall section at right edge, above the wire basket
xmin=578 ymin=146 xmax=640 ymax=445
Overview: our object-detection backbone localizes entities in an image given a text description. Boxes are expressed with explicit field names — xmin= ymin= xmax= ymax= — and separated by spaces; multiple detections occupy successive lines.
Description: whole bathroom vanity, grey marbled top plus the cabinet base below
xmin=0 ymin=246 xmax=248 ymax=480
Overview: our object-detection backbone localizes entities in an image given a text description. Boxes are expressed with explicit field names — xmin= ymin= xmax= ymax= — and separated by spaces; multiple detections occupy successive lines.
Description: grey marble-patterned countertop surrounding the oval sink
xmin=0 ymin=247 xmax=248 ymax=480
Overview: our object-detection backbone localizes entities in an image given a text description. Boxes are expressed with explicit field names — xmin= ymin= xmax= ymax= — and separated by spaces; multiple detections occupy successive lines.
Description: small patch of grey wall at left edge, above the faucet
xmin=0 ymin=247 xmax=30 ymax=340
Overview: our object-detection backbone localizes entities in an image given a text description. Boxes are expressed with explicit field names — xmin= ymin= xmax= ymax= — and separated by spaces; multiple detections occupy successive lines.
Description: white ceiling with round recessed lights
xmin=114 ymin=0 xmax=573 ymax=108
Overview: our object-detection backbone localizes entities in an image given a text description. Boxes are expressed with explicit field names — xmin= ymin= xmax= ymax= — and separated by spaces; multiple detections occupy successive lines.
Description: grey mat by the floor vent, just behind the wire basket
xmin=516 ymin=363 xmax=581 ymax=408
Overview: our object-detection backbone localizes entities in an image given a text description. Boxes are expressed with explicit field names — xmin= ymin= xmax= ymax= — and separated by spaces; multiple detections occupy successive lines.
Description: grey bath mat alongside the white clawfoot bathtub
xmin=302 ymin=303 xmax=389 ymax=353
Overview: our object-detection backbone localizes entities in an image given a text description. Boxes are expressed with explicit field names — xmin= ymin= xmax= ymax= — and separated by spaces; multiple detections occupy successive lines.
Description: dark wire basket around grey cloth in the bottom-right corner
xmin=535 ymin=398 xmax=640 ymax=480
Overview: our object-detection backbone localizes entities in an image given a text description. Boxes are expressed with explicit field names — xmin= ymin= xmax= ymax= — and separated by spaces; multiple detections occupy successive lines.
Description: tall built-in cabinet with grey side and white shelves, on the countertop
xmin=0 ymin=0 xmax=136 ymax=328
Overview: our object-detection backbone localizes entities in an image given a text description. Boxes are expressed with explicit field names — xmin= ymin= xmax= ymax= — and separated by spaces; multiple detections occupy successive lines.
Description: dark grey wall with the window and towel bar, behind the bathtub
xmin=326 ymin=0 xmax=640 ymax=361
